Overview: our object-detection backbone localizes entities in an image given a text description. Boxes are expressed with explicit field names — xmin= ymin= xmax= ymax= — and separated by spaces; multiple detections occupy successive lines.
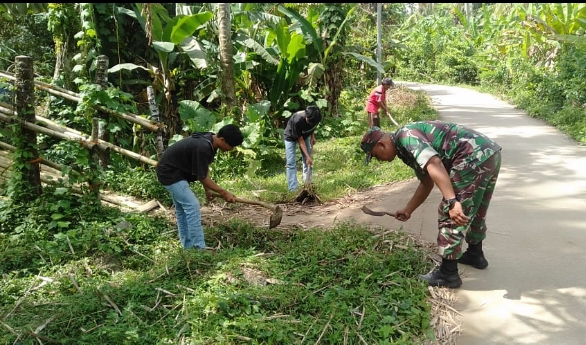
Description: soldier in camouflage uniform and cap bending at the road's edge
xmin=360 ymin=121 xmax=501 ymax=288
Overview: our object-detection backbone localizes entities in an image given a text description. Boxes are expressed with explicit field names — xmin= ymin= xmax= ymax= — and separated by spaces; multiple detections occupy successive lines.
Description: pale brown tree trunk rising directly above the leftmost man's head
xmin=218 ymin=3 xmax=236 ymax=110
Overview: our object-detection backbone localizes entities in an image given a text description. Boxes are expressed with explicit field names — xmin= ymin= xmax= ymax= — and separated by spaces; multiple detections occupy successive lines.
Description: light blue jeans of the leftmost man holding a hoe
xmin=164 ymin=180 xmax=206 ymax=249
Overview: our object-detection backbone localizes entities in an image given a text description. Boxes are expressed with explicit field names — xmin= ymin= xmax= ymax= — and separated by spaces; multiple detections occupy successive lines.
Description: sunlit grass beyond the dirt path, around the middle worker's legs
xmin=208 ymin=87 xmax=437 ymax=202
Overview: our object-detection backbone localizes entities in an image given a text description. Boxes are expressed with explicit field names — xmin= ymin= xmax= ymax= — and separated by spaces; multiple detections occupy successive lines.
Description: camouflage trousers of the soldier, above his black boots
xmin=437 ymin=152 xmax=501 ymax=260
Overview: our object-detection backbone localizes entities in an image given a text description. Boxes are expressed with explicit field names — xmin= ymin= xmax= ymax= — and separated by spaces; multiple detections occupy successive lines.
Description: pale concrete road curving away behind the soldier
xmin=400 ymin=83 xmax=586 ymax=345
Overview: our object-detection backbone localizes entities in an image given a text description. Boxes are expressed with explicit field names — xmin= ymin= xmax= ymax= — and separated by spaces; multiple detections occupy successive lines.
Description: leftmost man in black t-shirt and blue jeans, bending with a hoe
xmin=155 ymin=124 xmax=244 ymax=249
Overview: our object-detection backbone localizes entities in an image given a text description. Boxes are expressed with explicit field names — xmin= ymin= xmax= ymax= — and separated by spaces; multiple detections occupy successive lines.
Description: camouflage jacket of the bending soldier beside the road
xmin=391 ymin=121 xmax=501 ymax=179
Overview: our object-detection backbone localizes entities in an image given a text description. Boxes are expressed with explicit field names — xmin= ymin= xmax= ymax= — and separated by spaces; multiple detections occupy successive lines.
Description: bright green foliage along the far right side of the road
xmin=384 ymin=3 xmax=586 ymax=142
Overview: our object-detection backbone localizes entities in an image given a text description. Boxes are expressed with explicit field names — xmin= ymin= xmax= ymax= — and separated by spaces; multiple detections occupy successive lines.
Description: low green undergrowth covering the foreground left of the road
xmin=0 ymin=215 xmax=430 ymax=344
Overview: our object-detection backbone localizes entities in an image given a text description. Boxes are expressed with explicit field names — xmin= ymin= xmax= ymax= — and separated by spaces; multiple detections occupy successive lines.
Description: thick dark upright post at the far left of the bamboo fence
xmin=14 ymin=55 xmax=42 ymax=199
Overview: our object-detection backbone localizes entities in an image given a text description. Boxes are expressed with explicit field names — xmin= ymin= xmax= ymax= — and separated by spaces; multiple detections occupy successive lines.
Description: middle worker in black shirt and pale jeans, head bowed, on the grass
xmin=283 ymin=105 xmax=321 ymax=191
